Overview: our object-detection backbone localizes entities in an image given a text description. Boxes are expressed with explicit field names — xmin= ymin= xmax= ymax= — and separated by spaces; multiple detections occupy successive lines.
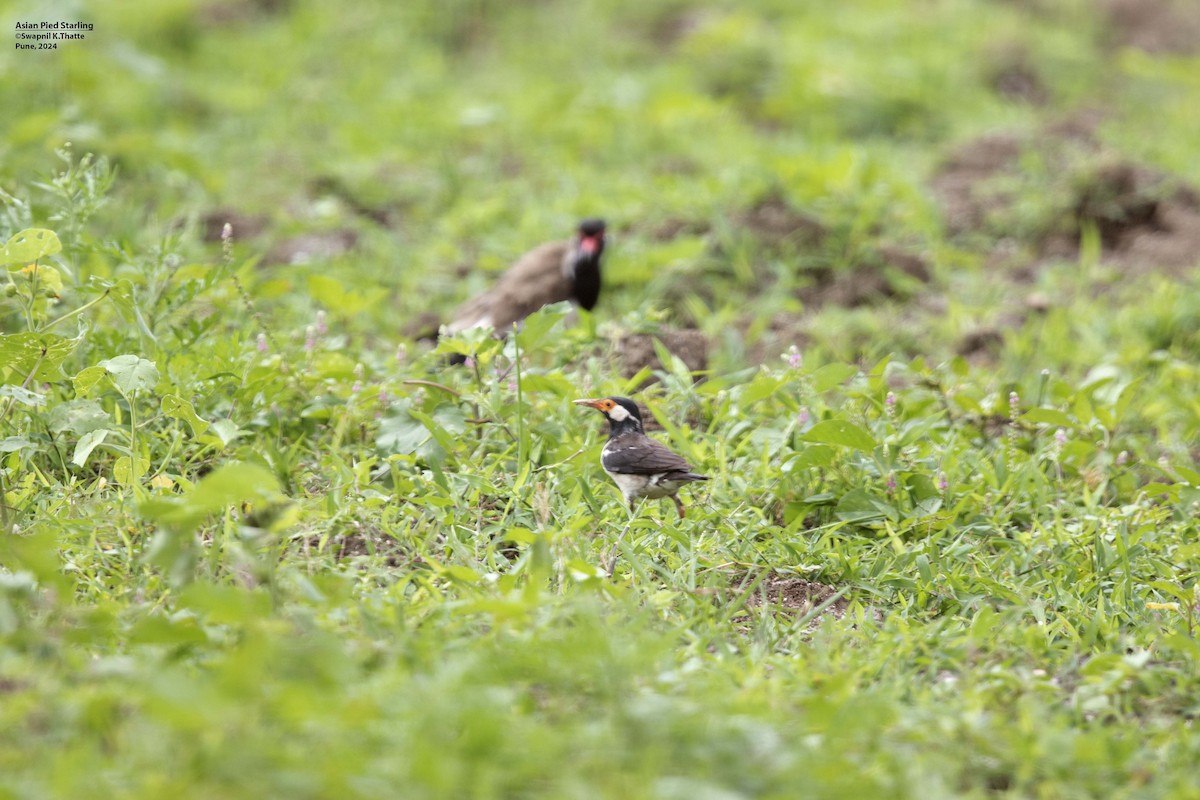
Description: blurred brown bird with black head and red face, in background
xmin=446 ymin=219 xmax=605 ymax=333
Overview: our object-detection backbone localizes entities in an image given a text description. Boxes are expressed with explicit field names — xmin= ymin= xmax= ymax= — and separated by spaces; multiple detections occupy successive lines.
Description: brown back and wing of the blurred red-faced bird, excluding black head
xmin=446 ymin=242 xmax=571 ymax=333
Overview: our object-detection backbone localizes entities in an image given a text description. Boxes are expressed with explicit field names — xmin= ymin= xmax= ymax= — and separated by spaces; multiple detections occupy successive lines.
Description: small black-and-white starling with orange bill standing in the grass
xmin=575 ymin=397 xmax=708 ymax=519
